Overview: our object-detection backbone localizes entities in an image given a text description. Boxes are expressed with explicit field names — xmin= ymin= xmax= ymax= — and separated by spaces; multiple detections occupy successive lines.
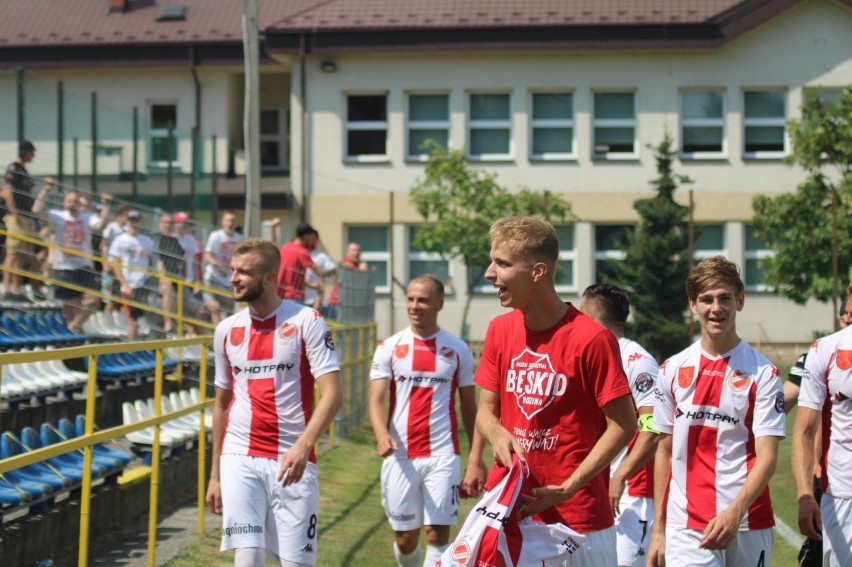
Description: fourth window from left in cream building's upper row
xmin=530 ymin=93 xmax=575 ymax=160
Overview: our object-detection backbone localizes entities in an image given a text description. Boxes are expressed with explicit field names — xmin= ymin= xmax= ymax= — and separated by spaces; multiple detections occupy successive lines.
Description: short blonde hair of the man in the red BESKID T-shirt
xmin=488 ymin=217 xmax=559 ymax=276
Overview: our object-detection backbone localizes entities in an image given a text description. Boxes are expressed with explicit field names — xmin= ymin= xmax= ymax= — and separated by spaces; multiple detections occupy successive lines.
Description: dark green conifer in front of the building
xmin=614 ymin=132 xmax=692 ymax=360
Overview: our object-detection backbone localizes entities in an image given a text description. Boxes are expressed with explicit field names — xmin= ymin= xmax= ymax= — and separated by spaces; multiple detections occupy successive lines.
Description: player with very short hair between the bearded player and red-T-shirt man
xmin=369 ymin=275 xmax=485 ymax=567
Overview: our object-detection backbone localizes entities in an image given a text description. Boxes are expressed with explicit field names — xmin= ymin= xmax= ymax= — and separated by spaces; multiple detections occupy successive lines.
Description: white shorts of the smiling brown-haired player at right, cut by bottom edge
xmin=666 ymin=526 xmax=775 ymax=567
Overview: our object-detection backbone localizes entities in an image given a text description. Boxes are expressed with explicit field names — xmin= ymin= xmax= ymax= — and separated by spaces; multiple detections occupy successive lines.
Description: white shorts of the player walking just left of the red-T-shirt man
xmin=382 ymin=455 xmax=461 ymax=532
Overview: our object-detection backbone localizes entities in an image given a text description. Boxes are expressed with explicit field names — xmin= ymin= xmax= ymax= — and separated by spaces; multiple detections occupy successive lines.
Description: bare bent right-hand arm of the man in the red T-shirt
xmin=523 ymin=394 xmax=636 ymax=516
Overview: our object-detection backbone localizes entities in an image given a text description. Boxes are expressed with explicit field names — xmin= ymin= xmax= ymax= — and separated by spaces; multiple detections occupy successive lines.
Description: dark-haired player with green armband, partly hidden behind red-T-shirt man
xmin=580 ymin=284 xmax=660 ymax=567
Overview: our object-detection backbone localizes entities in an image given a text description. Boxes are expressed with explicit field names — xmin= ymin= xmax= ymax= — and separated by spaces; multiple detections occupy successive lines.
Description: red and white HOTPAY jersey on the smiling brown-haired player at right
xmin=654 ymin=340 xmax=785 ymax=531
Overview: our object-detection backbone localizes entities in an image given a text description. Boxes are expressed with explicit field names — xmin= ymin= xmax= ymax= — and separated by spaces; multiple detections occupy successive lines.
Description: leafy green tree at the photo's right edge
xmin=752 ymin=87 xmax=852 ymax=319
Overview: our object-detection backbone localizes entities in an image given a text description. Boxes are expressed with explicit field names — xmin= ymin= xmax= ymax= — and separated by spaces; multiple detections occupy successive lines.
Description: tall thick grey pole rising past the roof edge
xmin=243 ymin=0 xmax=261 ymax=236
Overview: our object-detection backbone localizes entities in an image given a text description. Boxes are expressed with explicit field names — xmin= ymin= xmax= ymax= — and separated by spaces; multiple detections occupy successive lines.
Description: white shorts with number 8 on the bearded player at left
xmin=219 ymin=454 xmax=319 ymax=565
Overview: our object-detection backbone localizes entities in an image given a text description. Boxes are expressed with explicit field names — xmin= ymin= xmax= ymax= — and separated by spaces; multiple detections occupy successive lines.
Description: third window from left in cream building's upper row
xmin=468 ymin=94 xmax=512 ymax=160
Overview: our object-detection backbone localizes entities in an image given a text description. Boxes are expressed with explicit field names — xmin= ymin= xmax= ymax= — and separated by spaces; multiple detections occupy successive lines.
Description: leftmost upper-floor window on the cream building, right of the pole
xmin=346 ymin=94 xmax=388 ymax=161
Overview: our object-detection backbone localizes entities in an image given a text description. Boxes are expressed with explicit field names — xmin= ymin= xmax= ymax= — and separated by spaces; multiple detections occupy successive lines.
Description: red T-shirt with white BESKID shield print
xmin=475 ymin=303 xmax=630 ymax=533
